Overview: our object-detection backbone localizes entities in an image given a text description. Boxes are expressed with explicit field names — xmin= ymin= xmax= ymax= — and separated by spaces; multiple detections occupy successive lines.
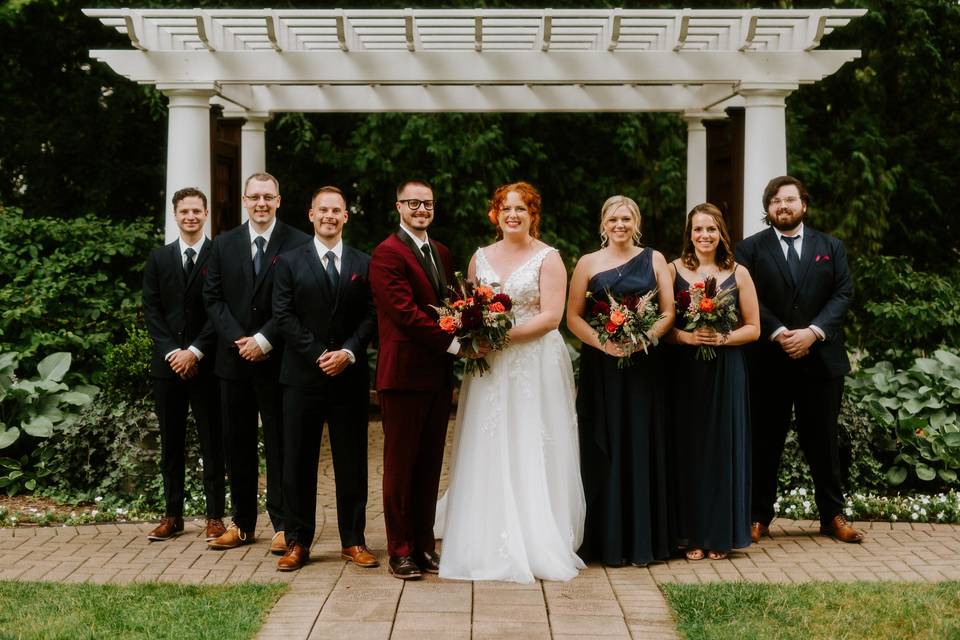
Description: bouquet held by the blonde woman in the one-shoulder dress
xmin=587 ymin=289 xmax=663 ymax=368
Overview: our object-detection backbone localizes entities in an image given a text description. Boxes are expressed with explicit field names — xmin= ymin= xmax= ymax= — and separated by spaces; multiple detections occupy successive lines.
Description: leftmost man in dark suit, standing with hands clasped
xmin=143 ymin=187 xmax=225 ymax=541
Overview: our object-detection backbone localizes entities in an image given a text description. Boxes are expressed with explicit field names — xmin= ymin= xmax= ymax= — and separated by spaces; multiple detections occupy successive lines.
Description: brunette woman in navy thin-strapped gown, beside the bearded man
xmin=667 ymin=203 xmax=760 ymax=560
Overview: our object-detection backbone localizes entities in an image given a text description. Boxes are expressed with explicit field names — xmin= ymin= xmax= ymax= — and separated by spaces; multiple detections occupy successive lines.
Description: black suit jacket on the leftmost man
xmin=143 ymin=240 xmax=217 ymax=378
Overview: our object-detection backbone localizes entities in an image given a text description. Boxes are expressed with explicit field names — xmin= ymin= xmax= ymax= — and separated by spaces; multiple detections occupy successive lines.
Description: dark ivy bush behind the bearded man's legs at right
xmin=779 ymin=393 xmax=893 ymax=493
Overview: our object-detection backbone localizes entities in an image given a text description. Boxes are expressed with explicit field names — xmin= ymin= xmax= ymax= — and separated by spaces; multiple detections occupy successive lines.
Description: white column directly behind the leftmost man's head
xmin=160 ymin=87 xmax=214 ymax=242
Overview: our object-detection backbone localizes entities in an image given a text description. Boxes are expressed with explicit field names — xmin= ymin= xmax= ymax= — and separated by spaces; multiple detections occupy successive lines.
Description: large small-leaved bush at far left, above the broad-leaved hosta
xmin=0 ymin=207 xmax=160 ymax=382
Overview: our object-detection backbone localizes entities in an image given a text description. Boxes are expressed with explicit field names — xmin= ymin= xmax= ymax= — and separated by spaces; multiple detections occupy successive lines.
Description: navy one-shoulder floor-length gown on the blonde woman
xmin=577 ymin=248 xmax=670 ymax=566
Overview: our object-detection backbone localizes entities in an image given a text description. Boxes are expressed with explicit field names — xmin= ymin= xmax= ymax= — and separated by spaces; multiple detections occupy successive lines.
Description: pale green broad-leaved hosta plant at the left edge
xmin=0 ymin=352 xmax=98 ymax=495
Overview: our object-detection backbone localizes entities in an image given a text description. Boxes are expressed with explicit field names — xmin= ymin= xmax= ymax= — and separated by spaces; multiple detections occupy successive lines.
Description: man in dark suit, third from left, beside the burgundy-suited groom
xmin=273 ymin=187 xmax=377 ymax=571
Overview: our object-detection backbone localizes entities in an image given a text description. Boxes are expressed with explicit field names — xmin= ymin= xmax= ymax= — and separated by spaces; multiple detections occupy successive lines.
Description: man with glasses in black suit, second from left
xmin=203 ymin=173 xmax=310 ymax=554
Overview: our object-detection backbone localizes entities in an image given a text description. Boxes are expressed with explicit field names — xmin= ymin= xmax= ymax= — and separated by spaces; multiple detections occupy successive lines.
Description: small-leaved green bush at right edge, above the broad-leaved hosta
xmin=848 ymin=256 xmax=960 ymax=367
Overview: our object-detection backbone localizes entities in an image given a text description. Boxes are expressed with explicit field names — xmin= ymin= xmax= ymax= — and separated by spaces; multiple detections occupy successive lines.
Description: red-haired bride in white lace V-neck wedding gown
xmin=435 ymin=182 xmax=585 ymax=582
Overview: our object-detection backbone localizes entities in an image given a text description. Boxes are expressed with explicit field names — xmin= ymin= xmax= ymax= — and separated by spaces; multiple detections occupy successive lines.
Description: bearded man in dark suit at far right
xmin=734 ymin=176 xmax=863 ymax=542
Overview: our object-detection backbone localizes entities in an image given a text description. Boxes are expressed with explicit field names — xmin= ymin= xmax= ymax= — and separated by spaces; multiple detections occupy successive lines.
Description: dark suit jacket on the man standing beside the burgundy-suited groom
xmin=273 ymin=242 xmax=377 ymax=395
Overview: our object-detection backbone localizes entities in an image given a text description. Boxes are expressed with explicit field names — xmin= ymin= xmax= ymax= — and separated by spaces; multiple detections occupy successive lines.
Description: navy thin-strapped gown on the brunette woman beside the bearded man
xmin=667 ymin=273 xmax=751 ymax=553
